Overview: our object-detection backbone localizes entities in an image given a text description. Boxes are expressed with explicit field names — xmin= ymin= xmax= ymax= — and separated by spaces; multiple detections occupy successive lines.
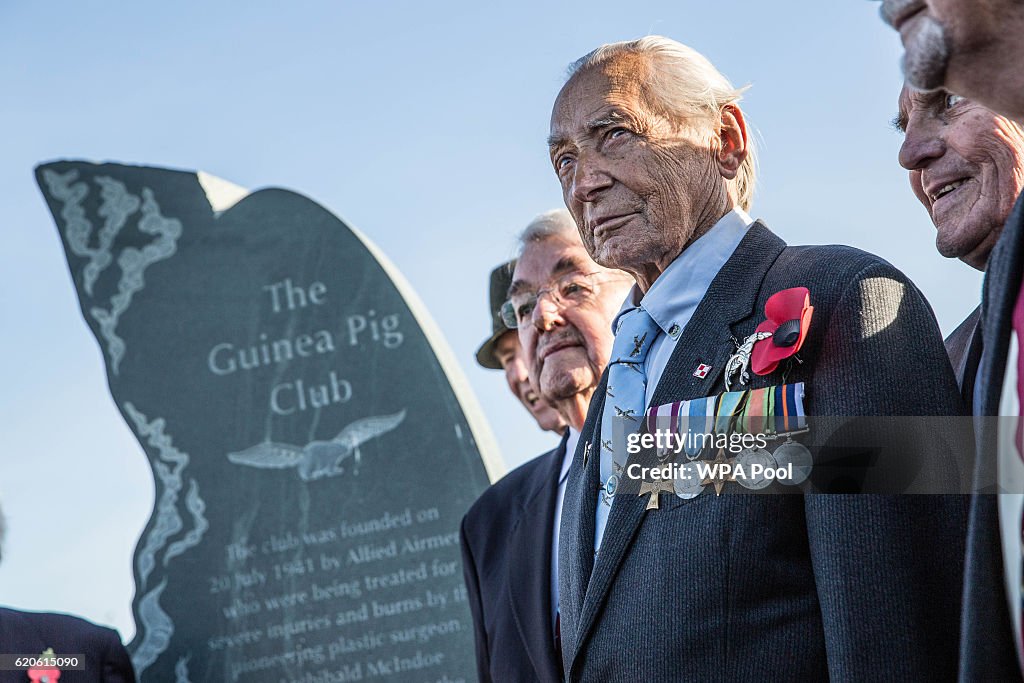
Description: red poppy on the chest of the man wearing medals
xmin=751 ymin=287 xmax=814 ymax=375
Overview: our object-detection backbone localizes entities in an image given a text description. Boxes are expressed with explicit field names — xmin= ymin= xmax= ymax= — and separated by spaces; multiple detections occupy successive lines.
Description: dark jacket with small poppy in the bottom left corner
xmin=0 ymin=607 xmax=135 ymax=683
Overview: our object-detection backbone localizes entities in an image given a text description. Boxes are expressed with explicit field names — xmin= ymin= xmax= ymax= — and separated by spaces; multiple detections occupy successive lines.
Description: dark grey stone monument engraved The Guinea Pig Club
xmin=36 ymin=161 xmax=498 ymax=682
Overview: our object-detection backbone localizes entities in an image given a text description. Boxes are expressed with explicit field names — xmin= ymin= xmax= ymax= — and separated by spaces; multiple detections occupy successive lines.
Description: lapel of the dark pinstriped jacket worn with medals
xmin=573 ymin=221 xmax=785 ymax=656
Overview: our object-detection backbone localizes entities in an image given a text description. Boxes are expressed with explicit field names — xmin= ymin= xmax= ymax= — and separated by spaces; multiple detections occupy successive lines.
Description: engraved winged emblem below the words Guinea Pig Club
xmin=227 ymin=409 xmax=406 ymax=481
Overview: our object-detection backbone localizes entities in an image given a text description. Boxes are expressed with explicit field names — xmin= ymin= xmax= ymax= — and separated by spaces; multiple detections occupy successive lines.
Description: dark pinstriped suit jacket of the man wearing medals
xmin=559 ymin=222 xmax=970 ymax=682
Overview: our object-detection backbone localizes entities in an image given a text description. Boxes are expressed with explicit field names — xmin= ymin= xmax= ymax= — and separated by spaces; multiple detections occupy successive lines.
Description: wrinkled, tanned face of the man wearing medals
xmin=549 ymin=57 xmax=724 ymax=273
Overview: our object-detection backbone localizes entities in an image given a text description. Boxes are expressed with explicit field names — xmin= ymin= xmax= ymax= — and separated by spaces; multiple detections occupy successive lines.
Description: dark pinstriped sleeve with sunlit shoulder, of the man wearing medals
xmin=805 ymin=262 xmax=970 ymax=681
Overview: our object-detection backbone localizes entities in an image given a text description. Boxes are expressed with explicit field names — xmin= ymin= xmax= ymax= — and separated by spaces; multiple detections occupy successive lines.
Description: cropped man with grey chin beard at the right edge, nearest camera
xmin=882 ymin=0 xmax=1024 ymax=681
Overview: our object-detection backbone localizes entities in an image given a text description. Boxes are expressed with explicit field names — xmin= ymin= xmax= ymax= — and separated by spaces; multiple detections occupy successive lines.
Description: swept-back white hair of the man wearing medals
xmin=565 ymin=36 xmax=757 ymax=211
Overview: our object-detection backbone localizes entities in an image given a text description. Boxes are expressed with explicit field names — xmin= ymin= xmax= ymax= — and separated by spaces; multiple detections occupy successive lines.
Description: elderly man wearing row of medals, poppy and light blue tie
xmin=549 ymin=37 xmax=967 ymax=681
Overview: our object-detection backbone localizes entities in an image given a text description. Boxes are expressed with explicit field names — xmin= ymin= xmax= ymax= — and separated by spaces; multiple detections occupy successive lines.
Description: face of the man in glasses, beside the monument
xmin=512 ymin=238 xmax=632 ymax=403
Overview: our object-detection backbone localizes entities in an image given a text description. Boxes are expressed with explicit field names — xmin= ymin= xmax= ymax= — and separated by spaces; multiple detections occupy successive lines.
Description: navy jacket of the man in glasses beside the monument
xmin=462 ymin=432 xmax=568 ymax=683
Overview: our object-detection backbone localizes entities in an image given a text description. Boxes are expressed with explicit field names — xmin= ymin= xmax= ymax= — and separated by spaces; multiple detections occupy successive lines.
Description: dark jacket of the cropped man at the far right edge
xmin=961 ymin=189 xmax=1024 ymax=681
